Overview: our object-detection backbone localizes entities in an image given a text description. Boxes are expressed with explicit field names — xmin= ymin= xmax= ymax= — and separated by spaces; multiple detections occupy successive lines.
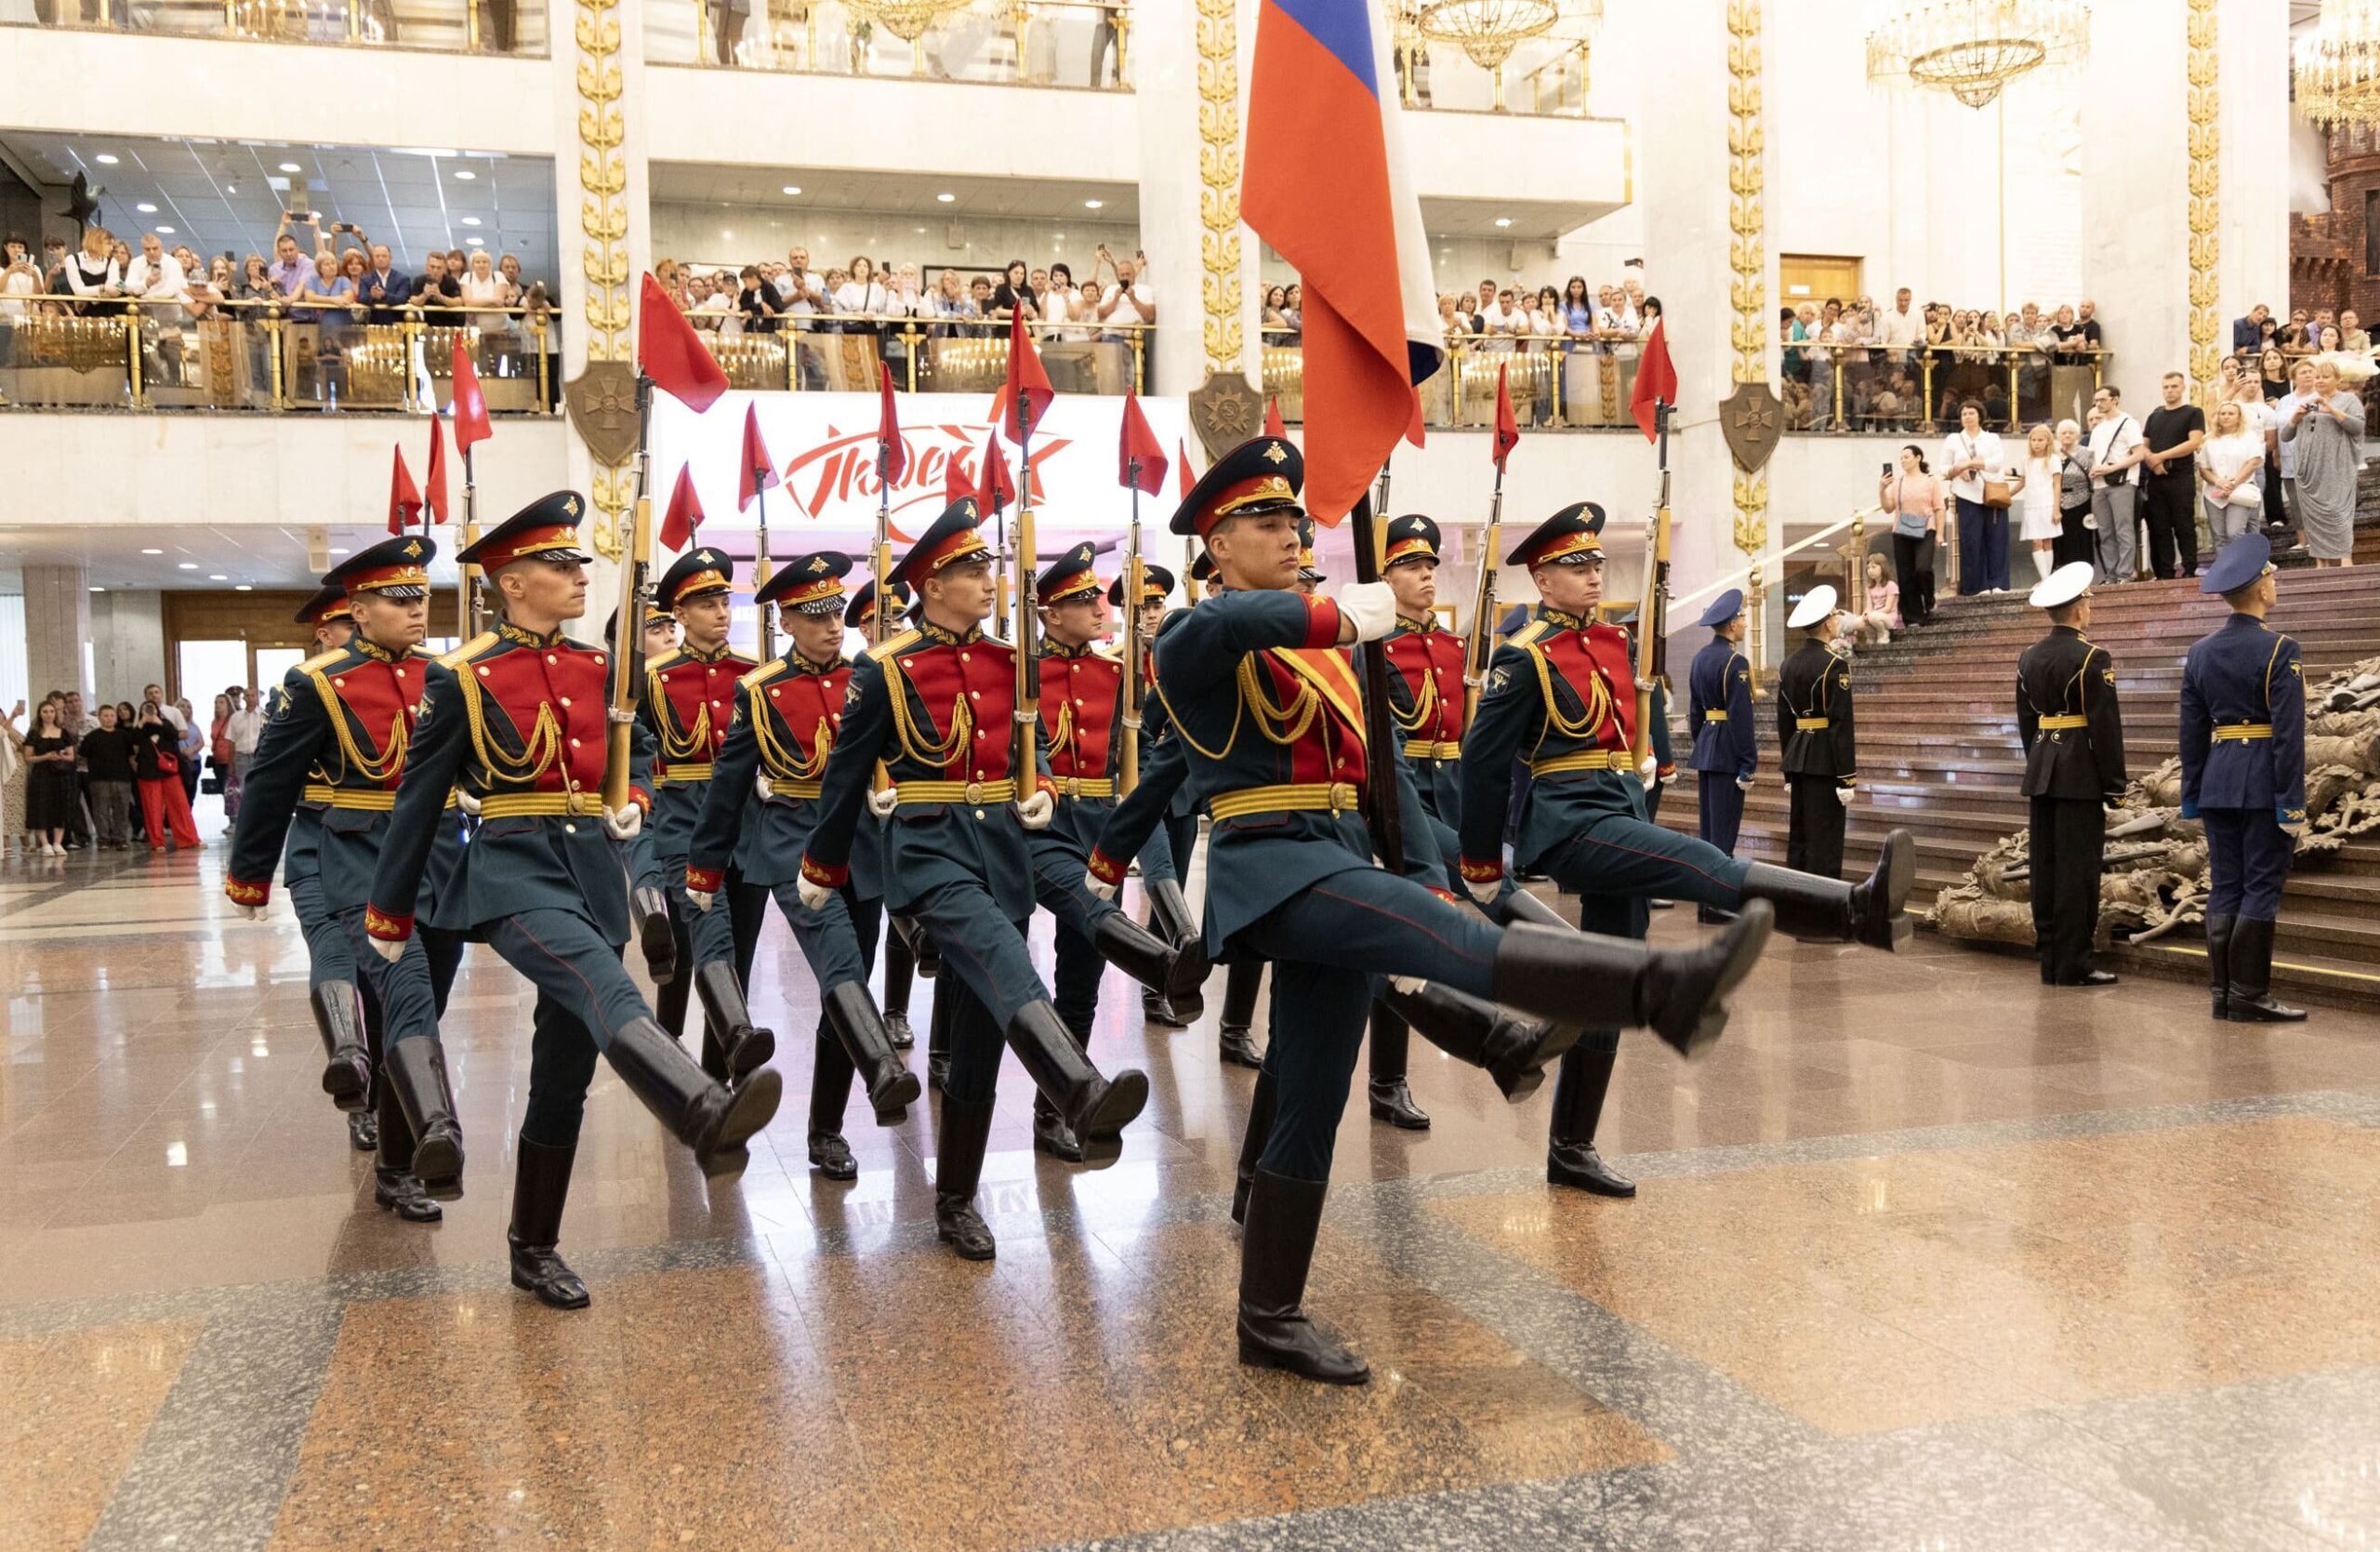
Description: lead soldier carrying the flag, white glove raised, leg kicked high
xmin=1157 ymin=435 xmax=1771 ymax=1383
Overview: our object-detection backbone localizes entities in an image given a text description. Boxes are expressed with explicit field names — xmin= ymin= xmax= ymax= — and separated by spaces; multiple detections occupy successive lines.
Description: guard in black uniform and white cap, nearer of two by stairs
xmin=2016 ymin=560 xmax=2125 ymax=986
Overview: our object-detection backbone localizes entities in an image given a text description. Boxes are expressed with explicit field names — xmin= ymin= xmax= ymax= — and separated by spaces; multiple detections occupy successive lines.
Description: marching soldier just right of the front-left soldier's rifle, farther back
xmin=636 ymin=545 xmax=771 ymax=1081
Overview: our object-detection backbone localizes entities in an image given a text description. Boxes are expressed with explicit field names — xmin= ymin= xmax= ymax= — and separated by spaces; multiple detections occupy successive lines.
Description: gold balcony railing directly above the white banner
xmin=697 ymin=314 xmax=1157 ymax=395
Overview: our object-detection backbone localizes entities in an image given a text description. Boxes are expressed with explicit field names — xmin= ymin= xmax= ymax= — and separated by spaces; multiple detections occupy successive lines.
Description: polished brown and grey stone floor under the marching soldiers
xmin=0 ymin=845 xmax=2380 ymax=1552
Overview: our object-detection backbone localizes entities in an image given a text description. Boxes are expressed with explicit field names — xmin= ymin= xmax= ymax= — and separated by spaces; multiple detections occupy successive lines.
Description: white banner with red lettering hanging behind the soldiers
xmin=652 ymin=392 xmax=1207 ymax=557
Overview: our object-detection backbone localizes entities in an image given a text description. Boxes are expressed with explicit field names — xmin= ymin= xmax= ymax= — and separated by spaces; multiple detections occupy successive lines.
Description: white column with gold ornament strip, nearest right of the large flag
xmin=1611 ymin=0 xmax=1776 ymax=629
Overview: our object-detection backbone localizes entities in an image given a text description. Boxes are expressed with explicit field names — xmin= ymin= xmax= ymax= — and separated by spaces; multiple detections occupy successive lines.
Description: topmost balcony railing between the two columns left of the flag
xmin=645 ymin=0 xmax=1133 ymax=90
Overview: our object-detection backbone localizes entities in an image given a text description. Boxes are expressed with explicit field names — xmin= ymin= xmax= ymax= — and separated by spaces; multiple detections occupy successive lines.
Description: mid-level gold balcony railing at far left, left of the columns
xmin=0 ymin=298 xmax=560 ymax=414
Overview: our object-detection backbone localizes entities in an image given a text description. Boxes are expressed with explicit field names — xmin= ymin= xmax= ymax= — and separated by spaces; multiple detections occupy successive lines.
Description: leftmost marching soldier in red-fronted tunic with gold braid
xmin=224 ymin=533 xmax=462 ymax=1224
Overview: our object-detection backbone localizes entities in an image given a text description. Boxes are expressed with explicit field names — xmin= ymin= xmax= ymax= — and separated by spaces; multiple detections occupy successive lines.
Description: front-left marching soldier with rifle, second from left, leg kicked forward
xmin=364 ymin=490 xmax=781 ymax=1309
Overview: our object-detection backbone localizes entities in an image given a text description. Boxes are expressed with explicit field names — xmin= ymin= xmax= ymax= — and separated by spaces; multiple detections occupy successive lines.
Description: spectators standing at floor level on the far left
xmin=0 ymin=685 xmax=264 ymax=857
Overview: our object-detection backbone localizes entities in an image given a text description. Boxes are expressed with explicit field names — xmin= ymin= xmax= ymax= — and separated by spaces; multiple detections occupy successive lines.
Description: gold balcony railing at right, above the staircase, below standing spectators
xmin=1782 ymin=340 xmax=2113 ymax=433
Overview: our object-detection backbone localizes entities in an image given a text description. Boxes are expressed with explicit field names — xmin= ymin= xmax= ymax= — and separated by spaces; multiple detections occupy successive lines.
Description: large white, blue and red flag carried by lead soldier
xmin=1240 ymin=0 xmax=1442 ymax=524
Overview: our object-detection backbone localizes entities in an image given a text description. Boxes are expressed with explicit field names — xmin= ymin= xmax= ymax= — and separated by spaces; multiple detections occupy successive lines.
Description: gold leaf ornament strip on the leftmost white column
xmin=576 ymin=0 xmax=636 ymax=562
